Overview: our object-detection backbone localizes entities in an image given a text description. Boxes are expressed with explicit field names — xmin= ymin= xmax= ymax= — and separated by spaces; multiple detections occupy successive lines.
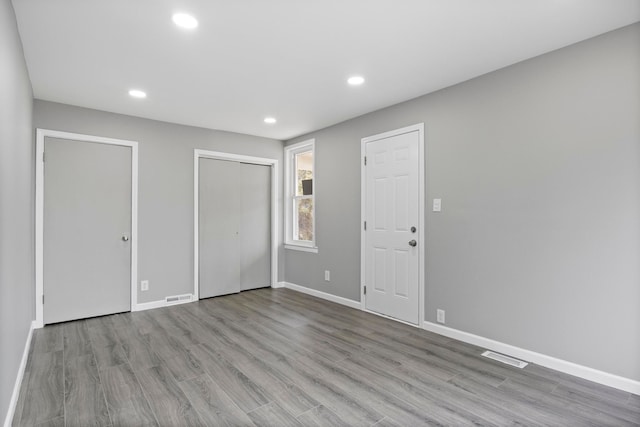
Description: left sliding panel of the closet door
xmin=198 ymin=159 xmax=240 ymax=298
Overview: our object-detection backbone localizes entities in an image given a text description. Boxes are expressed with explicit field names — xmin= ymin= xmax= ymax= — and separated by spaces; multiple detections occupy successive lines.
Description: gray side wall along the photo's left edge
xmin=0 ymin=0 xmax=35 ymax=421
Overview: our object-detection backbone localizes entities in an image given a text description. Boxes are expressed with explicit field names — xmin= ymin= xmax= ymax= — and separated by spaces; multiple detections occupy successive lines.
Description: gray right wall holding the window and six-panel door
xmin=285 ymin=24 xmax=640 ymax=380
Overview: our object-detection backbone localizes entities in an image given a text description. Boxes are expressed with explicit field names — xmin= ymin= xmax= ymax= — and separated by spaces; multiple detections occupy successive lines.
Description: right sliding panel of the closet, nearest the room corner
xmin=238 ymin=163 xmax=271 ymax=291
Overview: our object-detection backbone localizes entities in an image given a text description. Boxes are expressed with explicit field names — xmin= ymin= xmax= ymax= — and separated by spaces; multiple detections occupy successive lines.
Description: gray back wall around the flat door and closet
xmin=34 ymin=100 xmax=283 ymax=303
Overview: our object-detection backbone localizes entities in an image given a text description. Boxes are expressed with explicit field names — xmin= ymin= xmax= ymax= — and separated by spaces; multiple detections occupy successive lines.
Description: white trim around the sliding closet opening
xmin=193 ymin=149 xmax=278 ymax=301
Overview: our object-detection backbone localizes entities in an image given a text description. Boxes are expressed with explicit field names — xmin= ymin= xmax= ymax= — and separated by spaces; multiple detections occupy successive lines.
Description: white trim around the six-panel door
xmin=360 ymin=123 xmax=426 ymax=327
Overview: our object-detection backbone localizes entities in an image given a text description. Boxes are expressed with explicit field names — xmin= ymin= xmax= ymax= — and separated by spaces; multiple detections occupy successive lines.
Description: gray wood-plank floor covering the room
xmin=14 ymin=289 xmax=640 ymax=427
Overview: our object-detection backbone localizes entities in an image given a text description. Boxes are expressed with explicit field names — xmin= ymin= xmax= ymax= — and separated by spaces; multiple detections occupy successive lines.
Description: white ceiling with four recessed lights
xmin=13 ymin=0 xmax=640 ymax=140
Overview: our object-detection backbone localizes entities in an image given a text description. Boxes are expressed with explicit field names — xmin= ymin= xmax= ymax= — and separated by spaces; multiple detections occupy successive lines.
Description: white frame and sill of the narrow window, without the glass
xmin=284 ymin=139 xmax=318 ymax=253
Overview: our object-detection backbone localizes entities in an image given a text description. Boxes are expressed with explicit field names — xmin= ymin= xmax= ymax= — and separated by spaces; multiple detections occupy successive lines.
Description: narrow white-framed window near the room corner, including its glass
xmin=285 ymin=139 xmax=318 ymax=252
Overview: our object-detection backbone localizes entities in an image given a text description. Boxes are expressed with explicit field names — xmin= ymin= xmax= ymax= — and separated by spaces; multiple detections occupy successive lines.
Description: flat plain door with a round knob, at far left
xmin=43 ymin=137 xmax=132 ymax=324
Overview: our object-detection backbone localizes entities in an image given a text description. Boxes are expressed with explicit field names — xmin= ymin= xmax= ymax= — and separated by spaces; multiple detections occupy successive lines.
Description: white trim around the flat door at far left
xmin=35 ymin=129 xmax=138 ymax=328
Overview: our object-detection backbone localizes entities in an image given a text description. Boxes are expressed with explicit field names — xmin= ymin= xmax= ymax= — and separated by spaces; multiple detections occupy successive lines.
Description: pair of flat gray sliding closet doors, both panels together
xmin=198 ymin=158 xmax=271 ymax=298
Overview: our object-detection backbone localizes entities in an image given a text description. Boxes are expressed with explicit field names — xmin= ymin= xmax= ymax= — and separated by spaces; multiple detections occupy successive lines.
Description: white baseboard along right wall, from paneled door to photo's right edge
xmin=423 ymin=322 xmax=640 ymax=395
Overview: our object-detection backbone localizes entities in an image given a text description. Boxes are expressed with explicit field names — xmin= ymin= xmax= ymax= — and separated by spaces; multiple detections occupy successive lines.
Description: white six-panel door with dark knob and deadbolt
xmin=364 ymin=131 xmax=422 ymax=324
